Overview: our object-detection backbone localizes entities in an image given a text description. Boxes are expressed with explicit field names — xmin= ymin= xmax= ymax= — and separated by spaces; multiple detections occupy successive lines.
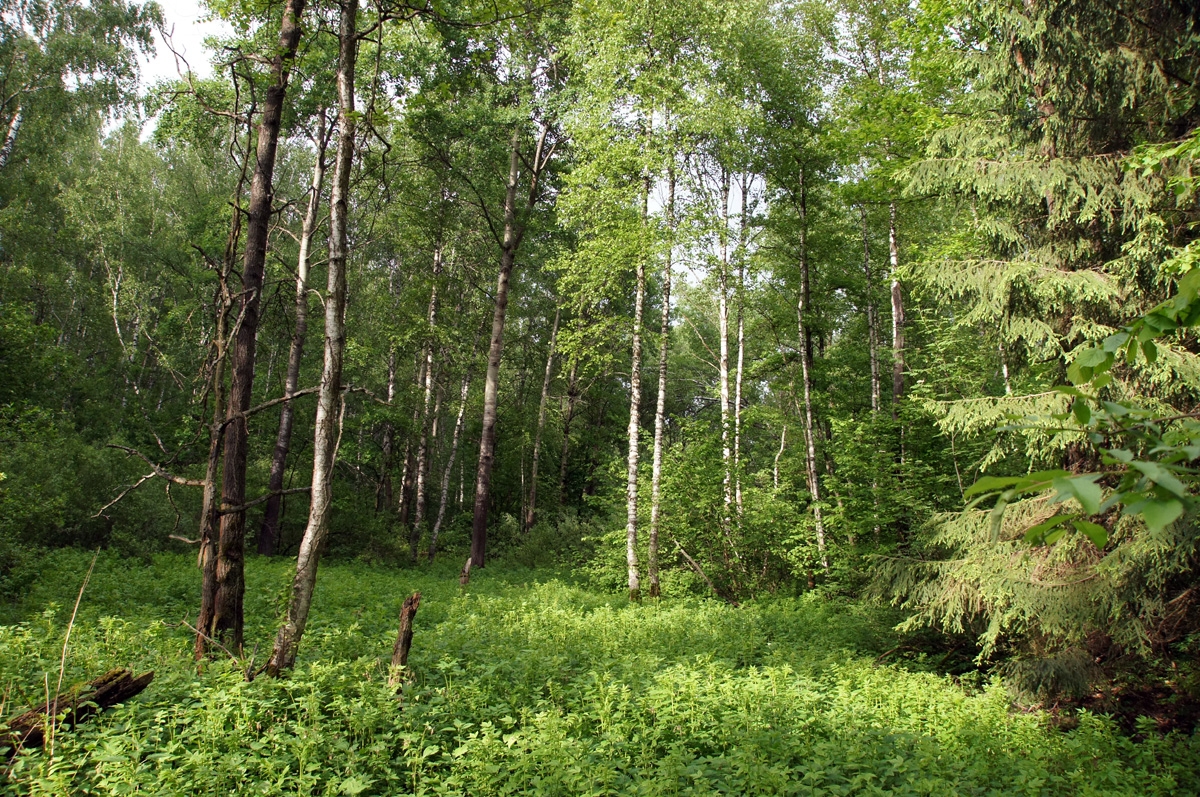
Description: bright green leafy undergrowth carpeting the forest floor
xmin=0 ymin=551 xmax=1200 ymax=797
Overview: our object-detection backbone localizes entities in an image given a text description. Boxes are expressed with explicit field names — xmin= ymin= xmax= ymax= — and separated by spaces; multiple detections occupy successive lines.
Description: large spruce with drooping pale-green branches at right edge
xmin=876 ymin=2 xmax=1200 ymax=700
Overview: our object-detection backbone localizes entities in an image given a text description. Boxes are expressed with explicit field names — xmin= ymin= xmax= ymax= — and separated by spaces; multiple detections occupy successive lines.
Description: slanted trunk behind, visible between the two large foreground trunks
xmin=258 ymin=118 xmax=326 ymax=556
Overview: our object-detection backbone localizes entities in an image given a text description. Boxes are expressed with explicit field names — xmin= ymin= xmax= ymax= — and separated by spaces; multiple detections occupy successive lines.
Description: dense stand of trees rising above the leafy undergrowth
xmin=0 ymin=0 xmax=1200 ymax=715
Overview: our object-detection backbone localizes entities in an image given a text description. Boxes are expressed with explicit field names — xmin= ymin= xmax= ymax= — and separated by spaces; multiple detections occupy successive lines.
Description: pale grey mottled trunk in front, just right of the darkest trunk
xmin=273 ymin=0 xmax=359 ymax=676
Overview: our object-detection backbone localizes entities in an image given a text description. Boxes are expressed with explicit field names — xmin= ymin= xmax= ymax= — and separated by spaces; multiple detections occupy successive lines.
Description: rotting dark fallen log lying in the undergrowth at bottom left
xmin=0 ymin=667 xmax=154 ymax=755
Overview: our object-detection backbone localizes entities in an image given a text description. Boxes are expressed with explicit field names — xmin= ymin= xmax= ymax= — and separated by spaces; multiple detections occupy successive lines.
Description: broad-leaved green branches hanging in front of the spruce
xmin=965 ymin=131 xmax=1200 ymax=550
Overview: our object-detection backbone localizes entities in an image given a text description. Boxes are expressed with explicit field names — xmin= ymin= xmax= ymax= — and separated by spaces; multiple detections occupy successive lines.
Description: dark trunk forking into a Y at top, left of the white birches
xmin=470 ymin=127 xmax=553 ymax=568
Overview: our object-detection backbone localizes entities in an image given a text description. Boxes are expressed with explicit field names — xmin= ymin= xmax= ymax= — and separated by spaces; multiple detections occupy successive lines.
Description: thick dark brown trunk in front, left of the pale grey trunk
xmin=212 ymin=0 xmax=305 ymax=652
